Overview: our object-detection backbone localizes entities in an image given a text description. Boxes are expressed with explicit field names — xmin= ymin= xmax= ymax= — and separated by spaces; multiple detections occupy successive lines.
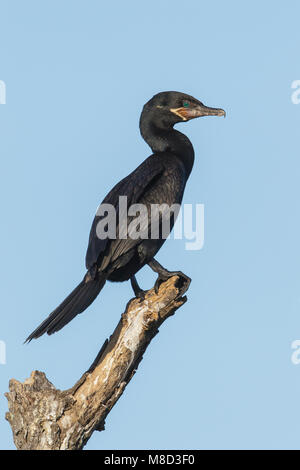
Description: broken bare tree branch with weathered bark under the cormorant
xmin=5 ymin=276 xmax=189 ymax=450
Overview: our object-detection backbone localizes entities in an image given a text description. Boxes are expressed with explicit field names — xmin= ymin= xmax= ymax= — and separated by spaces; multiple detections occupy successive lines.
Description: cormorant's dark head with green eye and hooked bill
xmin=142 ymin=91 xmax=226 ymax=127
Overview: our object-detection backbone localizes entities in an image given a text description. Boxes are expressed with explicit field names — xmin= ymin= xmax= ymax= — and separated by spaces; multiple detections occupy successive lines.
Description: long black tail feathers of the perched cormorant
xmin=25 ymin=273 xmax=106 ymax=343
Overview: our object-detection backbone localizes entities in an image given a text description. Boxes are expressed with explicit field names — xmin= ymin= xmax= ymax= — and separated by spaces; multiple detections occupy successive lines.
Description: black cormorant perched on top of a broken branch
xmin=26 ymin=91 xmax=225 ymax=341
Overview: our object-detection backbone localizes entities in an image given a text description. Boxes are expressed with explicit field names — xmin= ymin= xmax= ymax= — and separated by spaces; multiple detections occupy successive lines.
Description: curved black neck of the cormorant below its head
xmin=140 ymin=121 xmax=194 ymax=178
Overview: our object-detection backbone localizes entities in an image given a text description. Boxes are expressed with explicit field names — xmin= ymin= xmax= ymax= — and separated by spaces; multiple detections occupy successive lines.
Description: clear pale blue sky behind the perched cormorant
xmin=0 ymin=0 xmax=300 ymax=449
